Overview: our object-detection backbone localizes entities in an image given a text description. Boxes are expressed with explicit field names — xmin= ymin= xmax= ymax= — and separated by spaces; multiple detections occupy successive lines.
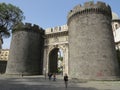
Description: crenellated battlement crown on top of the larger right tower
xmin=67 ymin=1 xmax=112 ymax=19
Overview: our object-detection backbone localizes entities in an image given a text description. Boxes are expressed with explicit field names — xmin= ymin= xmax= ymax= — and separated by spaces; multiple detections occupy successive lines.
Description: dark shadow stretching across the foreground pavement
xmin=0 ymin=78 xmax=98 ymax=90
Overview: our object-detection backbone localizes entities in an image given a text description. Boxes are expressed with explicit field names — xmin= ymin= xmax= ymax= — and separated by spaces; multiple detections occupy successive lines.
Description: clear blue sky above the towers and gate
xmin=0 ymin=0 xmax=120 ymax=49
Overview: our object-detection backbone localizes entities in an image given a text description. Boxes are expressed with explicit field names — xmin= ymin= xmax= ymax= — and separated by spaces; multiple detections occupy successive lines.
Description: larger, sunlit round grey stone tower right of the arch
xmin=67 ymin=2 xmax=119 ymax=80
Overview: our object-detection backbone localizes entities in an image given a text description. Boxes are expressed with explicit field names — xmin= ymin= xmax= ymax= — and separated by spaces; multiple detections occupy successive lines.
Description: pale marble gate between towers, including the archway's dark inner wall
xmin=43 ymin=25 xmax=68 ymax=74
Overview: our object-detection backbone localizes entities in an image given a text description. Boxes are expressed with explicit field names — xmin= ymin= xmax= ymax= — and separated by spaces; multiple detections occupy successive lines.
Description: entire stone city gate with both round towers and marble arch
xmin=6 ymin=2 xmax=120 ymax=80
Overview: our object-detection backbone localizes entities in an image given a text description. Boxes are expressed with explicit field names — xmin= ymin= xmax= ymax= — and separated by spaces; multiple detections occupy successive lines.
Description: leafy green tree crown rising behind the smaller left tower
xmin=0 ymin=3 xmax=25 ymax=38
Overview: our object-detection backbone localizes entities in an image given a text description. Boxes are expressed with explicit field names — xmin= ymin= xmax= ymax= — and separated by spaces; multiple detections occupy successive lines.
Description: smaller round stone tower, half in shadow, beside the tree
xmin=6 ymin=23 xmax=44 ymax=75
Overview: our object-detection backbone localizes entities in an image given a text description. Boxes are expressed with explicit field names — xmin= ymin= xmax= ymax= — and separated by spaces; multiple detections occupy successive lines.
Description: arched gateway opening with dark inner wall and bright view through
xmin=49 ymin=48 xmax=63 ymax=74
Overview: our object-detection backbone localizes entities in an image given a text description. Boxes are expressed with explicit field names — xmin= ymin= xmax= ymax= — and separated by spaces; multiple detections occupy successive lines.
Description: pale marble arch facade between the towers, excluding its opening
xmin=43 ymin=25 xmax=68 ymax=74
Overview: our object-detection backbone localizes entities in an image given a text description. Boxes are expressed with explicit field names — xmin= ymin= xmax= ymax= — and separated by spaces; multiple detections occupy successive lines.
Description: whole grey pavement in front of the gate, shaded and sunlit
xmin=0 ymin=76 xmax=120 ymax=90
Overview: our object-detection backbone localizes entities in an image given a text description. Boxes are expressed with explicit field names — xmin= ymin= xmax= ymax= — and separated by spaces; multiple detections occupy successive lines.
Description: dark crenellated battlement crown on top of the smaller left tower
xmin=13 ymin=23 xmax=45 ymax=34
